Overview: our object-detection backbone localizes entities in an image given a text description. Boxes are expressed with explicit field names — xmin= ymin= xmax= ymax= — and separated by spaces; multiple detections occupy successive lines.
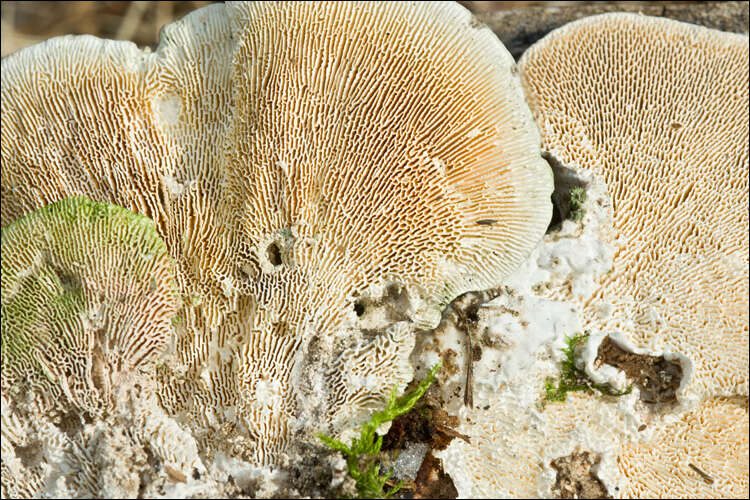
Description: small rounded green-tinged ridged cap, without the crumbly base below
xmin=1 ymin=197 xmax=177 ymax=415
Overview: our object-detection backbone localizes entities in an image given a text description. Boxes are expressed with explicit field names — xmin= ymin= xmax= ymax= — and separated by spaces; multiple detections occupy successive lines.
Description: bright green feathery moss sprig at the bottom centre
xmin=318 ymin=361 xmax=442 ymax=498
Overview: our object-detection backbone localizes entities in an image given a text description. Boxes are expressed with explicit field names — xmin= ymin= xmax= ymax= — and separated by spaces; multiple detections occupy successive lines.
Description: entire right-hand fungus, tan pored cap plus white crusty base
xmin=415 ymin=14 xmax=748 ymax=498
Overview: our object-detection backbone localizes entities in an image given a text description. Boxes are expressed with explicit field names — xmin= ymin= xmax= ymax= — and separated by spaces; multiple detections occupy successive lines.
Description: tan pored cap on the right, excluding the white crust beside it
xmin=519 ymin=14 xmax=748 ymax=397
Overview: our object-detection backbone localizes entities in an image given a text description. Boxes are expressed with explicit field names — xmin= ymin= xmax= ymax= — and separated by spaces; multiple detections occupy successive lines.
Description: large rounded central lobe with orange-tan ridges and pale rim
xmin=223 ymin=3 xmax=552 ymax=325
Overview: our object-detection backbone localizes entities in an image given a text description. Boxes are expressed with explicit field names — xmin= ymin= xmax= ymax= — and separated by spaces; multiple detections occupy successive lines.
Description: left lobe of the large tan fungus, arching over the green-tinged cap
xmin=0 ymin=5 xmax=238 ymax=304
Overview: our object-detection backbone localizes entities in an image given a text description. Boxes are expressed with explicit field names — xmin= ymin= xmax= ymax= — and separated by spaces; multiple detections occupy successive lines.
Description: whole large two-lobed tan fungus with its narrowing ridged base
xmin=0 ymin=2 xmax=553 ymax=464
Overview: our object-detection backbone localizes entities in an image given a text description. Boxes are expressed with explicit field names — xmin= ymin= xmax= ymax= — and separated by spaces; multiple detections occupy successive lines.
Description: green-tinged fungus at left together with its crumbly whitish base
xmin=0 ymin=197 xmax=209 ymax=497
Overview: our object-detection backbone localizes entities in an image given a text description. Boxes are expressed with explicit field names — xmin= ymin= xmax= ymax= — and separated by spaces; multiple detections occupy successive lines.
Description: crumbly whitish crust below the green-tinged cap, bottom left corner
xmin=0 ymin=390 xmax=205 ymax=498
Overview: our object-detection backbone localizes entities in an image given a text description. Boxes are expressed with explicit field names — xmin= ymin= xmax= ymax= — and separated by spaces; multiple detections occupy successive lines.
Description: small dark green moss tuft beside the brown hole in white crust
xmin=542 ymin=334 xmax=633 ymax=404
